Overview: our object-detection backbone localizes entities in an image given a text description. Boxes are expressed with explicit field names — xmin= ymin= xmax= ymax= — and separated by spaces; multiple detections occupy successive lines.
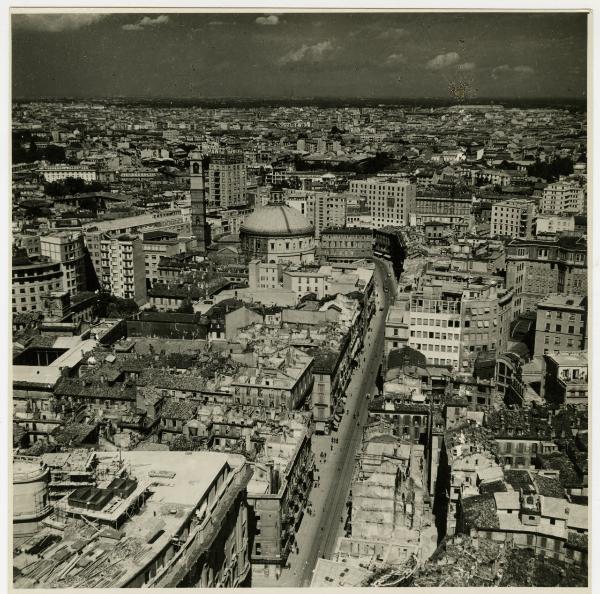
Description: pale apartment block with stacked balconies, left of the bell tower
xmin=87 ymin=232 xmax=147 ymax=305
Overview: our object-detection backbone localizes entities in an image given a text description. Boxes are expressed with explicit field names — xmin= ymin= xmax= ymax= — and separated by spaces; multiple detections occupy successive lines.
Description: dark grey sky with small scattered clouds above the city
xmin=12 ymin=12 xmax=587 ymax=99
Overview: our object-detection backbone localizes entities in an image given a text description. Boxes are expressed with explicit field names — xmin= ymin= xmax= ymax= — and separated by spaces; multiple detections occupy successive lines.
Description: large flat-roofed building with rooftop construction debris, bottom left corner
xmin=14 ymin=451 xmax=252 ymax=588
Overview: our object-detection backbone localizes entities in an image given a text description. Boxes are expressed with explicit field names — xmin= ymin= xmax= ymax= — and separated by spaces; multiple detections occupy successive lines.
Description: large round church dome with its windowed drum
xmin=240 ymin=205 xmax=315 ymax=264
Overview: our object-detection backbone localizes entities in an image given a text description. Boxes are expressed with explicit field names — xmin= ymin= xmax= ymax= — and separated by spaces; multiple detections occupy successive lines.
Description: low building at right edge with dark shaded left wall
xmin=541 ymin=351 xmax=588 ymax=407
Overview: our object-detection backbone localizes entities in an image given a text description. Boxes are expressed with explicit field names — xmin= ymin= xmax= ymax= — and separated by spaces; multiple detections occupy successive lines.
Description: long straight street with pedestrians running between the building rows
xmin=252 ymin=260 xmax=393 ymax=587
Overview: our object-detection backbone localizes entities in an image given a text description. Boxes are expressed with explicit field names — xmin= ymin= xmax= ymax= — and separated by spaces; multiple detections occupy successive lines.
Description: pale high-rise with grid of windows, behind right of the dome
xmin=350 ymin=177 xmax=417 ymax=229
